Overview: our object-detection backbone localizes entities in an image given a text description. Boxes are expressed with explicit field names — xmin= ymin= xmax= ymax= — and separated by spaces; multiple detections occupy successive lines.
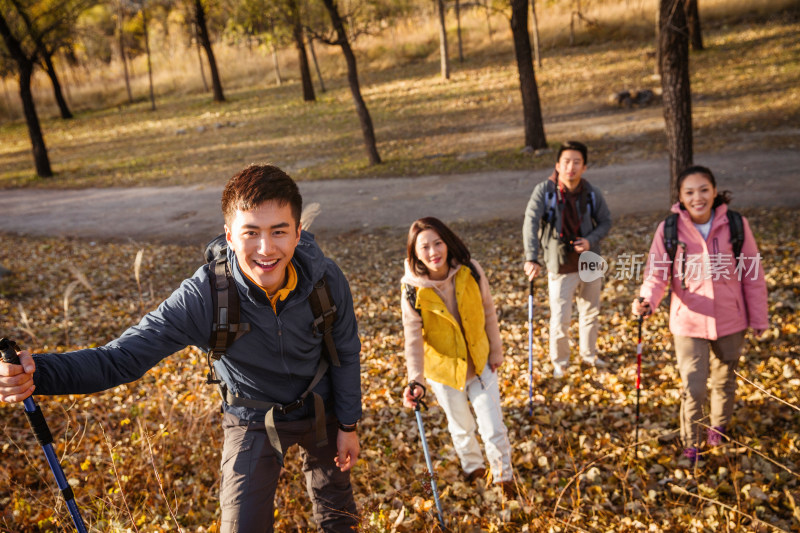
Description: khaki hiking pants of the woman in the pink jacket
xmin=675 ymin=331 xmax=744 ymax=448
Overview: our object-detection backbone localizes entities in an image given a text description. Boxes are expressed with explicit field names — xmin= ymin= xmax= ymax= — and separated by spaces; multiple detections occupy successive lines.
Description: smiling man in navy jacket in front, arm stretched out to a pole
xmin=0 ymin=165 xmax=361 ymax=533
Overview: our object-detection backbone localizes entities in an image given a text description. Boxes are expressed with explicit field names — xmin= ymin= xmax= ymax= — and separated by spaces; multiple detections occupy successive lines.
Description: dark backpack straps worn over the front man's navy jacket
xmin=204 ymin=234 xmax=341 ymax=465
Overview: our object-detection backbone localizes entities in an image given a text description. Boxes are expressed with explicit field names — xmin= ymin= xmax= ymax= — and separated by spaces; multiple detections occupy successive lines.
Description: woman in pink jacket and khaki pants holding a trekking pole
xmin=633 ymin=166 xmax=768 ymax=462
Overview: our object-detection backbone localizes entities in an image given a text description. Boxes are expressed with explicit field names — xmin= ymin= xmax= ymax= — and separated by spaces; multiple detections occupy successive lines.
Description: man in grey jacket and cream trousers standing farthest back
xmin=522 ymin=141 xmax=611 ymax=377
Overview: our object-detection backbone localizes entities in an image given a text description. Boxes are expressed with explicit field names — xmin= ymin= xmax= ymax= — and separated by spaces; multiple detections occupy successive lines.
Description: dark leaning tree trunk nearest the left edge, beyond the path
xmin=0 ymin=12 xmax=53 ymax=178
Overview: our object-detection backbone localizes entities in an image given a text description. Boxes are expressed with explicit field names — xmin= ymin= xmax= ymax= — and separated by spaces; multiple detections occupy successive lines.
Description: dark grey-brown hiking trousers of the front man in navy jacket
xmin=220 ymin=414 xmax=358 ymax=533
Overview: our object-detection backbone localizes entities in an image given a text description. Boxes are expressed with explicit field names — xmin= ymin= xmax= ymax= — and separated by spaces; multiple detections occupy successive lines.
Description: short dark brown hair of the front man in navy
xmin=222 ymin=165 xmax=303 ymax=227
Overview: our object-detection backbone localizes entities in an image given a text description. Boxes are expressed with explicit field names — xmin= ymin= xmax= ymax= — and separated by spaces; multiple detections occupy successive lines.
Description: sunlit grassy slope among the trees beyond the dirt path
xmin=0 ymin=0 xmax=800 ymax=187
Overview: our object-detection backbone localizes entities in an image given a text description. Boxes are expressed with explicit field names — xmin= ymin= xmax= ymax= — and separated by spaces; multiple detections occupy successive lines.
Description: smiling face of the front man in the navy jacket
xmin=225 ymin=200 xmax=300 ymax=295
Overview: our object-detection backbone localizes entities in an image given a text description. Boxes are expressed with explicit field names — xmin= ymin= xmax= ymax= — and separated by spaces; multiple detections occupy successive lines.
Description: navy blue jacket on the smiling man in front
xmin=34 ymin=232 xmax=361 ymax=424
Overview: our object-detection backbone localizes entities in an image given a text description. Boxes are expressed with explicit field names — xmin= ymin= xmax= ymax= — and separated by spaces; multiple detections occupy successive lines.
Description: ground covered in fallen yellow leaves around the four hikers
xmin=0 ymin=206 xmax=800 ymax=532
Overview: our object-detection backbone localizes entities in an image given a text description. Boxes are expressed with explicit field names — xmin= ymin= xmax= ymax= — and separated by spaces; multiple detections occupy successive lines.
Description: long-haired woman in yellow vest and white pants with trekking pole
xmin=401 ymin=217 xmax=514 ymax=496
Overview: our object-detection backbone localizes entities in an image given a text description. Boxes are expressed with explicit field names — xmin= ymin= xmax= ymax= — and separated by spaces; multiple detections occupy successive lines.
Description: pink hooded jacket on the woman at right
xmin=639 ymin=203 xmax=769 ymax=340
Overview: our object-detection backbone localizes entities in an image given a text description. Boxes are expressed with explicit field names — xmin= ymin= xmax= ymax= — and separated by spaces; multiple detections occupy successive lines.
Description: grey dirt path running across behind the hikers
xmin=0 ymin=150 xmax=800 ymax=244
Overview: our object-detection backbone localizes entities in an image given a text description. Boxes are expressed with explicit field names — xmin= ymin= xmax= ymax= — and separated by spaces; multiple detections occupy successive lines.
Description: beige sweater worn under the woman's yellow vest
xmin=400 ymin=259 xmax=503 ymax=383
